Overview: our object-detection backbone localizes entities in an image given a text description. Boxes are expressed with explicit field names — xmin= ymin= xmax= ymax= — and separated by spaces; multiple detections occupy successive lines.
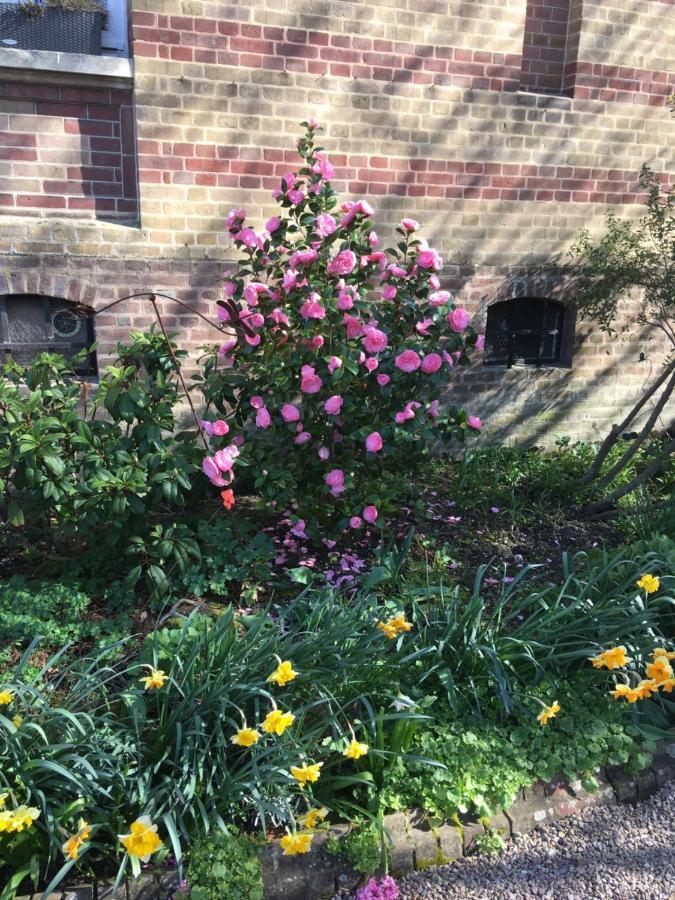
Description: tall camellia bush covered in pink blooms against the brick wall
xmin=199 ymin=122 xmax=483 ymax=538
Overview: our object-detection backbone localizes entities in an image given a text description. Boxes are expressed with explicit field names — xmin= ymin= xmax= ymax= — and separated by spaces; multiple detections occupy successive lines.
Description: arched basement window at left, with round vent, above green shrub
xmin=0 ymin=294 xmax=96 ymax=375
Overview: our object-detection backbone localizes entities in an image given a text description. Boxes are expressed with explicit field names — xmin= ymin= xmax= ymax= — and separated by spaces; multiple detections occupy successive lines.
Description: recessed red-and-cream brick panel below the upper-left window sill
xmin=0 ymin=82 xmax=138 ymax=220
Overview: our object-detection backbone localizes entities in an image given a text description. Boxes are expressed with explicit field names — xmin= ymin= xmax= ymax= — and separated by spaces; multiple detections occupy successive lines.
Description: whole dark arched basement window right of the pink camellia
xmin=485 ymin=297 xmax=574 ymax=368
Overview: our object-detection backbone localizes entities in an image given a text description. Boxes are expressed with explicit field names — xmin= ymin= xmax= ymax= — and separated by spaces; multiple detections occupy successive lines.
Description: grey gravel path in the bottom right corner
xmin=400 ymin=782 xmax=675 ymax=900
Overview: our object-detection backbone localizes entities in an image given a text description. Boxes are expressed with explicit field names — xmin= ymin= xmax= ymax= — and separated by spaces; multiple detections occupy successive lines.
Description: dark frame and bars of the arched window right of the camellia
xmin=484 ymin=294 xmax=576 ymax=369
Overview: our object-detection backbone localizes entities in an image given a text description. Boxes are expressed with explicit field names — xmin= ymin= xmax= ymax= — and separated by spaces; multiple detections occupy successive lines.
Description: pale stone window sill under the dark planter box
xmin=0 ymin=47 xmax=134 ymax=87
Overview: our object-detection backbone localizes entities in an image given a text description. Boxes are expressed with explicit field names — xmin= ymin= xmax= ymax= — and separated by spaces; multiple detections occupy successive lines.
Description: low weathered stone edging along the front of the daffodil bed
xmin=18 ymin=742 xmax=675 ymax=900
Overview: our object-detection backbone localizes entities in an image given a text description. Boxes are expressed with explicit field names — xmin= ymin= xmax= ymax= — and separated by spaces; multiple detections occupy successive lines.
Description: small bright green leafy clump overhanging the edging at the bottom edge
xmin=188 ymin=831 xmax=263 ymax=900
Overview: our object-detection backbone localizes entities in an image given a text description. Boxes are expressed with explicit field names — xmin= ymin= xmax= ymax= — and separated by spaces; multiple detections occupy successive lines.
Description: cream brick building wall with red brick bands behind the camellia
xmin=0 ymin=0 xmax=675 ymax=441
